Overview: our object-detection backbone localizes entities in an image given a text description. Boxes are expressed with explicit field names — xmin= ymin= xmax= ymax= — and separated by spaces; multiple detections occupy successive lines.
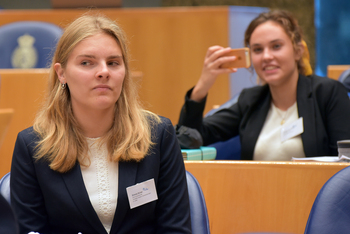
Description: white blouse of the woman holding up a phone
xmin=253 ymin=102 xmax=305 ymax=161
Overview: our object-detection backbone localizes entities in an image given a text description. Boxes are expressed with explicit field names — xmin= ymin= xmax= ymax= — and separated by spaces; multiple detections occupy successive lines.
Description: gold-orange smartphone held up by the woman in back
xmin=220 ymin=47 xmax=250 ymax=68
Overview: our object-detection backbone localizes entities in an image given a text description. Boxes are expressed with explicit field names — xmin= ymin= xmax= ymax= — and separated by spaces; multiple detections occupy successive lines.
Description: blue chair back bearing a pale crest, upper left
xmin=0 ymin=21 xmax=63 ymax=68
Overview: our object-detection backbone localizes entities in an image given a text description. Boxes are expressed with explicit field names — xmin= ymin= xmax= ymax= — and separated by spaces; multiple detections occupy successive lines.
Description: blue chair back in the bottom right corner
xmin=305 ymin=167 xmax=350 ymax=234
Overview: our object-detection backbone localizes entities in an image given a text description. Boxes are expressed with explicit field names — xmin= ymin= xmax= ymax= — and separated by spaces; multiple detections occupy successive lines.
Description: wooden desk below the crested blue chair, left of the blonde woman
xmin=0 ymin=69 xmax=48 ymax=177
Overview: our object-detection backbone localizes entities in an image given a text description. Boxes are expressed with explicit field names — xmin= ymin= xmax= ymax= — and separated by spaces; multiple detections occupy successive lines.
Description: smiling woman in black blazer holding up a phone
xmin=178 ymin=10 xmax=350 ymax=161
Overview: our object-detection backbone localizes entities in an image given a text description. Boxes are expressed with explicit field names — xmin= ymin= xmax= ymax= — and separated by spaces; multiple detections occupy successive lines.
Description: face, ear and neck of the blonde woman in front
xmin=54 ymin=33 xmax=125 ymax=138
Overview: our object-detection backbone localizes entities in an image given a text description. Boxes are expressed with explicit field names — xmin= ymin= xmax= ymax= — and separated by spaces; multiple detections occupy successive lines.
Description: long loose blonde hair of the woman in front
xmin=33 ymin=15 xmax=160 ymax=173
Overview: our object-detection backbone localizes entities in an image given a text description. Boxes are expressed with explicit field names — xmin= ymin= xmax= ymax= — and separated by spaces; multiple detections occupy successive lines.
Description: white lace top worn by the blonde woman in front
xmin=81 ymin=138 xmax=118 ymax=233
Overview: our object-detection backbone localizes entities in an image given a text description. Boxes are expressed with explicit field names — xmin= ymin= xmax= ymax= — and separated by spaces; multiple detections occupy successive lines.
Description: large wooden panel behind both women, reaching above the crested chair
xmin=0 ymin=6 xmax=231 ymax=124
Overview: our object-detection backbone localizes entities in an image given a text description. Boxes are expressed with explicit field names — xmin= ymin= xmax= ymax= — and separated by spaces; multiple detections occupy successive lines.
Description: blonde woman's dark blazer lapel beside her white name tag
xmin=110 ymin=162 xmax=138 ymax=233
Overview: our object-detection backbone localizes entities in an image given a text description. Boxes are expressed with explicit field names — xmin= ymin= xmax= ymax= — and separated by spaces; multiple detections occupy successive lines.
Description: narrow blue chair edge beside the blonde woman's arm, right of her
xmin=186 ymin=171 xmax=210 ymax=234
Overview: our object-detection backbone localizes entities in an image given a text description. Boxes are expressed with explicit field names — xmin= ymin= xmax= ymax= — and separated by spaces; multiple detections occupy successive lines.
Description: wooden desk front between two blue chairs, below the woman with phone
xmin=185 ymin=161 xmax=350 ymax=234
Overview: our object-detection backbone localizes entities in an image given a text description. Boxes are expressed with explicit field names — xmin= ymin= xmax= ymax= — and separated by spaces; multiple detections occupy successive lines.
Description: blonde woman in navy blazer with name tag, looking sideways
xmin=11 ymin=15 xmax=191 ymax=234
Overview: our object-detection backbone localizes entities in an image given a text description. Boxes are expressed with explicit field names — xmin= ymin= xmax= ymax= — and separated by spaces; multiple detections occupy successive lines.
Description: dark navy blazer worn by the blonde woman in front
xmin=11 ymin=118 xmax=191 ymax=234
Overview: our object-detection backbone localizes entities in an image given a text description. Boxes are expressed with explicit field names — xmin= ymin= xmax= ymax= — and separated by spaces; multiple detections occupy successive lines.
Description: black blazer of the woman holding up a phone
xmin=178 ymin=75 xmax=350 ymax=160
